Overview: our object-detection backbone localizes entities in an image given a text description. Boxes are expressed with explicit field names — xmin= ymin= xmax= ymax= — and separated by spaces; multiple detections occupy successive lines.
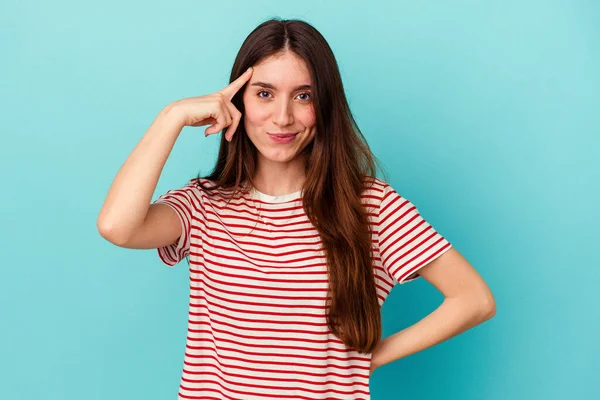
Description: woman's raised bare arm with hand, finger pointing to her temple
xmin=96 ymin=68 xmax=252 ymax=249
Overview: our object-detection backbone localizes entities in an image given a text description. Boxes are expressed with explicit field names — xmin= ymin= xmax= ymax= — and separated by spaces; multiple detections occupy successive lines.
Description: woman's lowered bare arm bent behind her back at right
xmin=371 ymin=247 xmax=496 ymax=373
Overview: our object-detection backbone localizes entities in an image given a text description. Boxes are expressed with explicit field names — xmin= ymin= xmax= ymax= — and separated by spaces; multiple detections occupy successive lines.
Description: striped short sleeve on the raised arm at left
xmin=153 ymin=179 xmax=200 ymax=267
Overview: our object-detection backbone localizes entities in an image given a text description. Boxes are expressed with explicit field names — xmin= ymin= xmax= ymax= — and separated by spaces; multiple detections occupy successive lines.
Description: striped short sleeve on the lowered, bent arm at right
xmin=378 ymin=185 xmax=452 ymax=284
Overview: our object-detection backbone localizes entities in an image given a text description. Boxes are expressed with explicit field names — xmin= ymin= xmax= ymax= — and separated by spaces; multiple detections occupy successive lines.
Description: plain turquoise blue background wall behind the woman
xmin=0 ymin=0 xmax=600 ymax=400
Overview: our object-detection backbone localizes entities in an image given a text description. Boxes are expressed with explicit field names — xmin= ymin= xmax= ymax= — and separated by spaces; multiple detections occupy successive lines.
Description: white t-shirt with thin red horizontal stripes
xmin=155 ymin=178 xmax=451 ymax=400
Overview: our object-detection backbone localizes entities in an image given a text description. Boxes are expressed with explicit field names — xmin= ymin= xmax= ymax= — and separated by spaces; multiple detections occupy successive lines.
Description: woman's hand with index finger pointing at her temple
xmin=170 ymin=68 xmax=252 ymax=141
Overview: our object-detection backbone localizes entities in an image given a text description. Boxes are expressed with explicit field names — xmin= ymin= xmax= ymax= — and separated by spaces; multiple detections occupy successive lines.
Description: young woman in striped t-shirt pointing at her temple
xmin=97 ymin=20 xmax=495 ymax=399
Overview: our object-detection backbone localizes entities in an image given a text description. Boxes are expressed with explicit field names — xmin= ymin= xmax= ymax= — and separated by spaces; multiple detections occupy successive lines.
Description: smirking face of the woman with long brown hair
xmin=243 ymin=51 xmax=316 ymax=163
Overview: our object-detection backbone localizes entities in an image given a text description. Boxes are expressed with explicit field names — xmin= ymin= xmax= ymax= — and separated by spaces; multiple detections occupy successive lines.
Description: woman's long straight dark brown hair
xmin=198 ymin=19 xmax=381 ymax=353
